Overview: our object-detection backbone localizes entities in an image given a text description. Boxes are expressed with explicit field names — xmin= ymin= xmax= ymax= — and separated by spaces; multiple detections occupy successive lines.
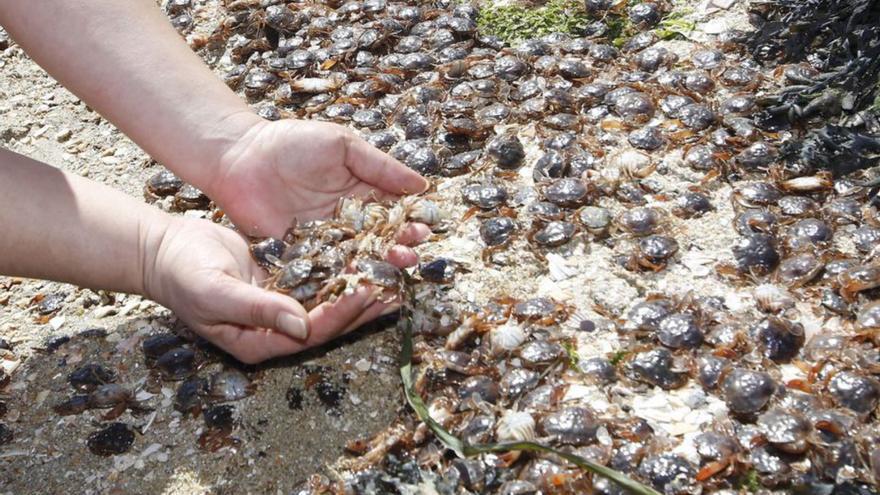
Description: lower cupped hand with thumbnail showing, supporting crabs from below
xmin=143 ymin=217 xmax=404 ymax=363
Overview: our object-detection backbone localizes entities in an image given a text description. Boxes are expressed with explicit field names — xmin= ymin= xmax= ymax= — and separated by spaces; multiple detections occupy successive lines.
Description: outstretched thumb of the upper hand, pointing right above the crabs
xmin=344 ymin=132 xmax=428 ymax=194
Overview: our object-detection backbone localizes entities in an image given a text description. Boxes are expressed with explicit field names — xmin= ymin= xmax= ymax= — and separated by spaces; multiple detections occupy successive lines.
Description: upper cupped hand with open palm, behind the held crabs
xmin=207 ymin=120 xmax=428 ymax=237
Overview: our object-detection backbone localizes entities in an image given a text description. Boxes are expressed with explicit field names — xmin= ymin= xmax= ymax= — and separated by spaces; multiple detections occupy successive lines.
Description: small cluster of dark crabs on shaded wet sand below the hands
xmin=46 ymin=329 xmax=255 ymax=456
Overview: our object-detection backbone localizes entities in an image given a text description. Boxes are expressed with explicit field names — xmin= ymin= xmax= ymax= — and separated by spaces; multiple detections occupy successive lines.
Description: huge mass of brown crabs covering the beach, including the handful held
xmin=134 ymin=0 xmax=880 ymax=494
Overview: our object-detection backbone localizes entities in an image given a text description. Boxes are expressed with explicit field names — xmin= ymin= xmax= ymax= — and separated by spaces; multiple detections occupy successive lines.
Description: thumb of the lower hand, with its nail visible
xmin=212 ymin=277 xmax=309 ymax=340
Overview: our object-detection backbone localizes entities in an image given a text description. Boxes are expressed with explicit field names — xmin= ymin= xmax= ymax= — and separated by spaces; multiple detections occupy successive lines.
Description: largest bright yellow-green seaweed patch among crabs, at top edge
xmin=477 ymin=0 xmax=591 ymax=43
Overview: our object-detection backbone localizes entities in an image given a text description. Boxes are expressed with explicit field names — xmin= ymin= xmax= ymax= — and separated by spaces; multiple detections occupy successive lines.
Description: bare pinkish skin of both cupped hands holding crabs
xmin=154 ymin=119 xmax=430 ymax=363
